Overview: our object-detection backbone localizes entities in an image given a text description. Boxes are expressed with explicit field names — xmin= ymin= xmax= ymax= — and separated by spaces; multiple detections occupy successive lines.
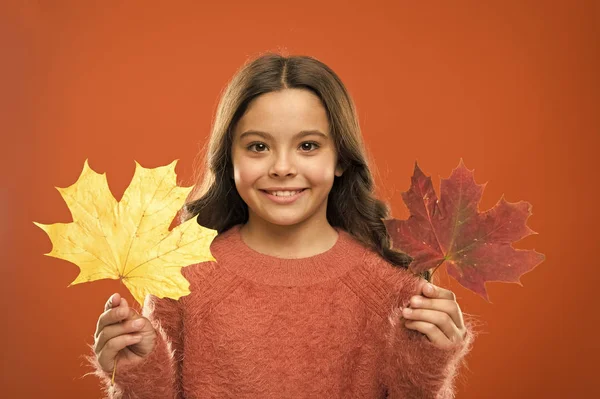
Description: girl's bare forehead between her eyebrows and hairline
xmin=234 ymin=89 xmax=329 ymax=137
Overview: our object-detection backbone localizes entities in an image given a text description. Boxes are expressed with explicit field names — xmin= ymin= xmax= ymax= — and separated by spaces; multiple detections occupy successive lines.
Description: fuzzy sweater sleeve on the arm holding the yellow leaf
xmin=86 ymin=295 xmax=184 ymax=399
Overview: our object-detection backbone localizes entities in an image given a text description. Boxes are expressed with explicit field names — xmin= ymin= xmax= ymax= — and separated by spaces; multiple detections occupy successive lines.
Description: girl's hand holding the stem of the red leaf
xmin=402 ymin=283 xmax=467 ymax=349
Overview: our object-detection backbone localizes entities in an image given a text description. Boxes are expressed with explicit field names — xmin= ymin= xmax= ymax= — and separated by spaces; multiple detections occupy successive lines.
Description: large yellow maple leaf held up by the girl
xmin=33 ymin=159 xmax=217 ymax=305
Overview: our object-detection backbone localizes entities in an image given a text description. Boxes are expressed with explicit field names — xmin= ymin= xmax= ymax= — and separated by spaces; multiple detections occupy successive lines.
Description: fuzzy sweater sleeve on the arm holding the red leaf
xmin=382 ymin=271 xmax=475 ymax=399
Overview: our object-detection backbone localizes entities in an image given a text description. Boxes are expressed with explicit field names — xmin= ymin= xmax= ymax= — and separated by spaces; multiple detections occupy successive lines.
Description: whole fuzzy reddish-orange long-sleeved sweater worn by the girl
xmin=88 ymin=225 xmax=474 ymax=399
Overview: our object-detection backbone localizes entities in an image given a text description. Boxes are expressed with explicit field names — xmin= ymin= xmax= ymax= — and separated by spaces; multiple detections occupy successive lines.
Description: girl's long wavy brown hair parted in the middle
xmin=181 ymin=53 xmax=431 ymax=281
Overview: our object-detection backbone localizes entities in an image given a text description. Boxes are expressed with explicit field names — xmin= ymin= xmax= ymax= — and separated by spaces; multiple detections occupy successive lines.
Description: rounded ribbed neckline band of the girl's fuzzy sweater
xmin=210 ymin=224 xmax=366 ymax=287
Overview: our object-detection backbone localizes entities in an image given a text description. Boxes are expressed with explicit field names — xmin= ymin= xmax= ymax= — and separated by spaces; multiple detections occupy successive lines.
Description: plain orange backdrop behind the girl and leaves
xmin=0 ymin=0 xmax=600 ymax=399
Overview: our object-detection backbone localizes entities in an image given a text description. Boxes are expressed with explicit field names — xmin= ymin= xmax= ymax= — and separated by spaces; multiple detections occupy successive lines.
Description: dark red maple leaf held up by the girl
xmin=384 ymin=159 xmax=545 ymax=302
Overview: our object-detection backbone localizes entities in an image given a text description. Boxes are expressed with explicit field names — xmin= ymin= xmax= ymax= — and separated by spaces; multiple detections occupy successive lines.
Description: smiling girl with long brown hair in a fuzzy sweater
xmin=89 ymin=54 xmax=474 ymax=399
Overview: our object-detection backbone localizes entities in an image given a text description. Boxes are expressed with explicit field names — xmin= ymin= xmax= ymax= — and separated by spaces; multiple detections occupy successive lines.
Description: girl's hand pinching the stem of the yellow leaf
xmin=94 ymin=293 xmax=156 ymax=372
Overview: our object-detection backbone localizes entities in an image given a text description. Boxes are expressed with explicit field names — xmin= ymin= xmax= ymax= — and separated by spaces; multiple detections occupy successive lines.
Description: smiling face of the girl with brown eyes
xmin=231 ymin=89 xmax=342 ymax=230
